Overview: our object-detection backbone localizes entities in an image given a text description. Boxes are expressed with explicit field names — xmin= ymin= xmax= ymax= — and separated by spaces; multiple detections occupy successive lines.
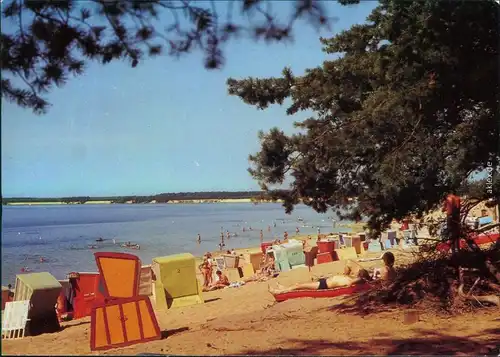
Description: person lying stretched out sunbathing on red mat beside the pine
xmin=269 ymin=269 xmax=372 ymax=295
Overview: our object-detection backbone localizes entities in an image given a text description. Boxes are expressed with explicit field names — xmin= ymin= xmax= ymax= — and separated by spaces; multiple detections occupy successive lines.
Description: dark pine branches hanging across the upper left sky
xmin=0 ymin=0 xmax=336 ymax=113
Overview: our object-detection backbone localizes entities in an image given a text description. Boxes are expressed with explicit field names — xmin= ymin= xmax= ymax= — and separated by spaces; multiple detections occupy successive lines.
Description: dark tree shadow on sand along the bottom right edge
xmin=238 ymin=329 xmax=500 ymax=356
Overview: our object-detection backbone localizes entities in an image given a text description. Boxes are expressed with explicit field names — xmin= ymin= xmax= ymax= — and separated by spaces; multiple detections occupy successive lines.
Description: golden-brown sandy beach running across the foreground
xmin=2 ymin=246 xmax=500 ymax=355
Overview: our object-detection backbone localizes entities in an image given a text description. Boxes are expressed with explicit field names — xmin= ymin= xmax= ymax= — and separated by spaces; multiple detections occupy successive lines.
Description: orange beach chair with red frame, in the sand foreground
xmin=90 ymin=252 xmax=161 ymax=351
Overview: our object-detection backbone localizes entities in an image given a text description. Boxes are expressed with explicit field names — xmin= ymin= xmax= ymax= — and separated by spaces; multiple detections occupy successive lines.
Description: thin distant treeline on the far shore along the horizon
xmin=2 ymin=191 xmax=267 ymax=205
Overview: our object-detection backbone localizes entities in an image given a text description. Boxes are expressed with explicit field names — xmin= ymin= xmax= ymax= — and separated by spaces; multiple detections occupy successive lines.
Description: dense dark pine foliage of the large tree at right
xmin=228 ymin=0 xmax=500 ymax=234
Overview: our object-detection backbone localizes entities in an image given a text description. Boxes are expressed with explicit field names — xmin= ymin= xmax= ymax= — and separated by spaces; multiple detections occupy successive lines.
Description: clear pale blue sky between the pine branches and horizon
xmin=1 ymin=1 xmax=376 ymax=197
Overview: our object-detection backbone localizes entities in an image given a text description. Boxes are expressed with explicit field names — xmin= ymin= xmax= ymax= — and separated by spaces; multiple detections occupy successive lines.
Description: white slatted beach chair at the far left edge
xmin=2 ymin=300 xmax=30 ymax=340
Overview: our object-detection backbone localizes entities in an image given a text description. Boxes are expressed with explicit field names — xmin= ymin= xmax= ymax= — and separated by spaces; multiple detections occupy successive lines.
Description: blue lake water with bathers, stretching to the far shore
xmin=2 ymin=203 xmax=352 ymax=285
